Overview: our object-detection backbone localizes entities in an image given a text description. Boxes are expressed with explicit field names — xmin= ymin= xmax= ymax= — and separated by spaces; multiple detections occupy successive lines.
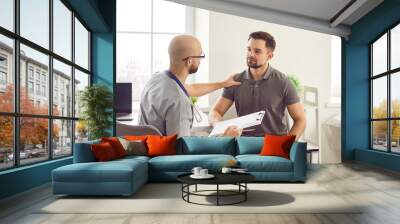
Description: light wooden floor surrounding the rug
xmin=0 ymin=163 xmax=400 ymax=224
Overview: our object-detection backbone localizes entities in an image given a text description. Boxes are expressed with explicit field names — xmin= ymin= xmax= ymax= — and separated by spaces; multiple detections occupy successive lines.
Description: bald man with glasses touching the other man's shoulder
xmin=139 ymin=35 xmax=241 ymax=137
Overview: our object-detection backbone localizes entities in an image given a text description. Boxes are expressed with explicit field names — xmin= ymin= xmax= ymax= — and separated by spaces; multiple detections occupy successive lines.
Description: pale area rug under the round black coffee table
xmin=36 ymin=183 xmax=360 ymax=214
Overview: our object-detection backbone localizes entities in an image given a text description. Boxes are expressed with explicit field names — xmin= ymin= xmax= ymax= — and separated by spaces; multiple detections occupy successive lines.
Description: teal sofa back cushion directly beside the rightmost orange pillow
xmin=236 ymin=137 xmax=264 ymax=155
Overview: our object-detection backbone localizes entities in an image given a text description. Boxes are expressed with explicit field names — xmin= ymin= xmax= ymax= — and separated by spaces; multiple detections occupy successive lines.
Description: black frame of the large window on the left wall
xmin=0 ymin=0 xmax=92 ymax=172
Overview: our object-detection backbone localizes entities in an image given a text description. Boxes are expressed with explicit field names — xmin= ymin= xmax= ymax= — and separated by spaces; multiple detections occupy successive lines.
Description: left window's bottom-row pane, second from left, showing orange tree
xmin=19 ymin=117 xmax=49 ymax=164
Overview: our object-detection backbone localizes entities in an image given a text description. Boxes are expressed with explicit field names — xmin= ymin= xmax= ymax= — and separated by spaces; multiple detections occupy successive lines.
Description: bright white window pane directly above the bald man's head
xmin=153 ymin=0 xmax=186 ymax=33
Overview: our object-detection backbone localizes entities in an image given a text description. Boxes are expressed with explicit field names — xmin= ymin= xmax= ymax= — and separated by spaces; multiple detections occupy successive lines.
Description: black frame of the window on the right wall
xmin=368 ymin=21 xmax=400 ymax=155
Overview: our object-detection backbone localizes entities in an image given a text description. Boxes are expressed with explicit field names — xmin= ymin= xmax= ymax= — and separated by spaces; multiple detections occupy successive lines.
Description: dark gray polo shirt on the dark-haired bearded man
xmin=222 ymin=65 xmax=300 ymax=136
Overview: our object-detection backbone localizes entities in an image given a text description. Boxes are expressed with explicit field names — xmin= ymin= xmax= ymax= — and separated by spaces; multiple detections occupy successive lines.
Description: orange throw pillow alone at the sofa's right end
xmin=260 ymin=135 xmax=296 ymax=159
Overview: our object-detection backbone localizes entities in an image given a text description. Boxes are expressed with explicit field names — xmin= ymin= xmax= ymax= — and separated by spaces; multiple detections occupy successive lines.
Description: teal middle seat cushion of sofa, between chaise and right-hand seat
xmin=149 ymin=154 xmax=235 ymax=172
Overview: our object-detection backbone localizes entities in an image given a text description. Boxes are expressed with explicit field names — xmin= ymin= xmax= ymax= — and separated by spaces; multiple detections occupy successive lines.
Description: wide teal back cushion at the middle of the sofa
xmin=177 ymin=136 xmax=235 ymax=155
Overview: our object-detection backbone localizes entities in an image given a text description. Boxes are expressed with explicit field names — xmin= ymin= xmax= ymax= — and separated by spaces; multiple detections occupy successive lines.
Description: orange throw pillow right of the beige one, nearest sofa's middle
xmin=146 ymin=135 xmax=178 ymax=157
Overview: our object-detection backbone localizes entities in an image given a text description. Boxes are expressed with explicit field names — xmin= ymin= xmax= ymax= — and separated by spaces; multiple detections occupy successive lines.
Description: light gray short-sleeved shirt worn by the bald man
xmin=139 ymin=71 xmax=193 ymax=137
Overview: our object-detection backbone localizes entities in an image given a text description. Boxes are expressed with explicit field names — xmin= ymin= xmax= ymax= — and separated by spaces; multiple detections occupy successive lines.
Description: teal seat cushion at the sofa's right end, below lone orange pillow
xmin=236 ymin=155 xmax=293 ymax=172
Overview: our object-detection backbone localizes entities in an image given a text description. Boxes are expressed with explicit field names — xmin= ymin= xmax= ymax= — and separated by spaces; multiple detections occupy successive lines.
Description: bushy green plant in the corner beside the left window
xmin=79 ymin=84 xmax=113 ymax=140
